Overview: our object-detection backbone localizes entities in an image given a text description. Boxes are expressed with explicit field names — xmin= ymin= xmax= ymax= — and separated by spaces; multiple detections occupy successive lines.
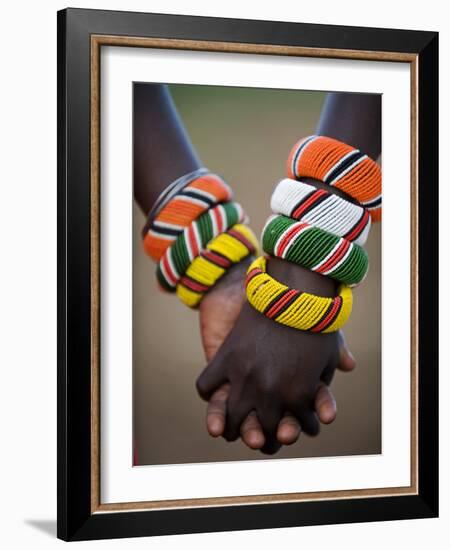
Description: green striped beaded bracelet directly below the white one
xmin=262 ymin=215 xmax=369 ymax=286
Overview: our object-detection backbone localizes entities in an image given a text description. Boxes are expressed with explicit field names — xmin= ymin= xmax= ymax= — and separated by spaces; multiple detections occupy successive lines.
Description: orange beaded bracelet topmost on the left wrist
xmin=142 ymin=169 xmax=233 ymax=261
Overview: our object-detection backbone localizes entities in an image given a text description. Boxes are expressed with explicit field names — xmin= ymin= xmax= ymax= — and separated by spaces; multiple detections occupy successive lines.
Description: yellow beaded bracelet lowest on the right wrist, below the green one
xmin=245 ymin=256 xmax=353 ymax=332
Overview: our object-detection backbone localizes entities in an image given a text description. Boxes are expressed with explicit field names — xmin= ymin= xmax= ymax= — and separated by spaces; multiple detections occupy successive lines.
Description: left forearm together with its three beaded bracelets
xmin=133 ymin=84 xmax=257 ymax=307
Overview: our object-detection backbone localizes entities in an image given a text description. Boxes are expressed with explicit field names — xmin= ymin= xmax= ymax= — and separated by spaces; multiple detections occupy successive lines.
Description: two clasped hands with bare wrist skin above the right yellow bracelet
xmin=196 ymin=179 xmax=356 ymax=454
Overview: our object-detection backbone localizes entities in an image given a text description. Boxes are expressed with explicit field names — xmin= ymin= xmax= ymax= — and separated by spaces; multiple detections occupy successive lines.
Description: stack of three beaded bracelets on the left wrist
xmin=142 ymin=168 xmax=258 ymax=308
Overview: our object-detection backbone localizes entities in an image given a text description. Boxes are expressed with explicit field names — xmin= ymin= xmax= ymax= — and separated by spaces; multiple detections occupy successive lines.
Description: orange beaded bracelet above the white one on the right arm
xmin=287 ymin=136 xmax=381 ymax=221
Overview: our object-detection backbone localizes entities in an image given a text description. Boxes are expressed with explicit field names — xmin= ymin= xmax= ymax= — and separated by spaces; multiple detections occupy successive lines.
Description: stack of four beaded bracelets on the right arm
xmin=245 ymin=136 xmax=381 ymax=332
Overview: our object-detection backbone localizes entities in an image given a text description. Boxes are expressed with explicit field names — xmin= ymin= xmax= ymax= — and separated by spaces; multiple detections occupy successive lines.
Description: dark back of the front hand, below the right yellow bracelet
xmin=197 ymin=303 xmax=339 ymax=452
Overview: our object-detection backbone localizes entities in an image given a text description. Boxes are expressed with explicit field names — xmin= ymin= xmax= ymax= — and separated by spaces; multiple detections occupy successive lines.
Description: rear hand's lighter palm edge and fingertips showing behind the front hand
xmin=200 ymin=262 xmax=355 ymax=452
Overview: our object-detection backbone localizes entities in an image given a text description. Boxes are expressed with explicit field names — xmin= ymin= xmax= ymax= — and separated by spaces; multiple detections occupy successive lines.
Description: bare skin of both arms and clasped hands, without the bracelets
xmin=133 ymin=83 xmax=374 ymax=454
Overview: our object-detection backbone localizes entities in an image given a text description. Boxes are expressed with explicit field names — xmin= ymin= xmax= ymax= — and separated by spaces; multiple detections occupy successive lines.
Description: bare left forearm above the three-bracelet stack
xmin=133 ymin=83 xmax=201 ymax=215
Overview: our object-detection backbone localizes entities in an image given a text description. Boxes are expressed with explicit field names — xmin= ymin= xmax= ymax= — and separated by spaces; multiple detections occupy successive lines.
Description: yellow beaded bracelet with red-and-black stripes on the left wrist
xmin=177 ymin=224 xmax=258 ymax=308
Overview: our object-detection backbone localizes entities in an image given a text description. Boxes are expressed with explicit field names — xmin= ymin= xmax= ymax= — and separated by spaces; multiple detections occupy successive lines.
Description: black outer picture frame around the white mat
xmin=57 ymin=9 xmax=438 ymax=541
